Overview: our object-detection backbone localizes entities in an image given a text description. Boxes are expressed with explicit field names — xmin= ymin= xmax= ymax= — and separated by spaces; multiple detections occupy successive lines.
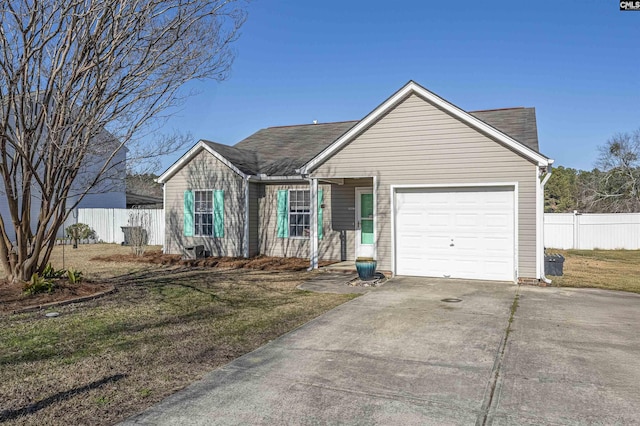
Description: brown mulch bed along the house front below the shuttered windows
xmin=91 ymin=250 xmax=334 ymax=271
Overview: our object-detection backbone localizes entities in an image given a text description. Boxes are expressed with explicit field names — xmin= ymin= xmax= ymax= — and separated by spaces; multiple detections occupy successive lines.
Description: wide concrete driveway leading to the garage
xmin=125 ymin=277 xmax=640 ymax=425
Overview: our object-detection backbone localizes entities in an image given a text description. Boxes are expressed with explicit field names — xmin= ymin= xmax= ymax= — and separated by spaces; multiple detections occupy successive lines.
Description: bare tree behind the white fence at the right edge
xmin=586 ymin=129 xmax=640 ymax=213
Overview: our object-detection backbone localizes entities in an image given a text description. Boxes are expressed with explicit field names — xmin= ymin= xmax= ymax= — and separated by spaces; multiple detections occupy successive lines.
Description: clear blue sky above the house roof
xmin=158 ymin=0 xmax=640 ymax=172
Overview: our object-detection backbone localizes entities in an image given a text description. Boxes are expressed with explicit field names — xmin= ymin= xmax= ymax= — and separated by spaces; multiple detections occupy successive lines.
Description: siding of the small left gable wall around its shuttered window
xmin=165 ymin=151 xmax=245 ymax=257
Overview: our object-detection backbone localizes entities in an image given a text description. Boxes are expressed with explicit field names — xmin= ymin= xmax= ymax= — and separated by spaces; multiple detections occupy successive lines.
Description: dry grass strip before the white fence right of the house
xmin=548 ymin=250 xmax=640 ymax=293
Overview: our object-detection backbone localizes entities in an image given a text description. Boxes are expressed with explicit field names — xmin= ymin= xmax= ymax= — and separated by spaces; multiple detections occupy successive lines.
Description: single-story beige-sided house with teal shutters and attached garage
xmin=158 ymin=81 xmax=553 ymax=282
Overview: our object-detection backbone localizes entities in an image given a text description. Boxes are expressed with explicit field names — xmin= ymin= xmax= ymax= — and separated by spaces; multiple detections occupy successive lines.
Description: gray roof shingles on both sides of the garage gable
xmin=204 ymin=107 xmax=538 ymax=176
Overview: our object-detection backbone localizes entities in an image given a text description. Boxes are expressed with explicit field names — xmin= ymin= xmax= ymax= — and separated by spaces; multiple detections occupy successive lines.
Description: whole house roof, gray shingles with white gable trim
xmin=158 ymin=81 xmax=553 ymax=182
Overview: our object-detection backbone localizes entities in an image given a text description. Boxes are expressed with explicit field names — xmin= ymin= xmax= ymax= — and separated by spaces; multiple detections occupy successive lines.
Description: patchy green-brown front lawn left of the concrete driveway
xmin=0 ymin=246 xmax=355 ymax=425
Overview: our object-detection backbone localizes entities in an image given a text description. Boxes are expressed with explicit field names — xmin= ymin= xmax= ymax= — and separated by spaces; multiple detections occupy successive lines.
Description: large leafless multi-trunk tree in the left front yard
xmin=0 ymin=0 xmax=245 ymax=282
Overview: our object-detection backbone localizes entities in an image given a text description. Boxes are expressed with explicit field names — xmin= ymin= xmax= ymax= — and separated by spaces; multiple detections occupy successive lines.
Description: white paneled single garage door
xmin=395 ymin=187 xmax=515 ymax=281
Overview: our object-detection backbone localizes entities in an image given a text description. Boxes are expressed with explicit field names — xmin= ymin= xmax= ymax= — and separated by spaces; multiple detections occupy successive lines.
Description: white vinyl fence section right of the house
xmin=544 ymin=213 xmax=640 ymax=250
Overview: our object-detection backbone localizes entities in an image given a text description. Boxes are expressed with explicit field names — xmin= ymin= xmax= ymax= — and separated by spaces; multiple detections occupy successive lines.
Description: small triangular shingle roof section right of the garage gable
xmin=469 ymin=107 xmax=539 ymax=152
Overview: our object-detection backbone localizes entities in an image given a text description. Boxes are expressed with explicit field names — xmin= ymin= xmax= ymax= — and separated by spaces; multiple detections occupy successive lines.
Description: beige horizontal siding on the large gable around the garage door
xmin=312 ymin=95 xmax=536 ymax=277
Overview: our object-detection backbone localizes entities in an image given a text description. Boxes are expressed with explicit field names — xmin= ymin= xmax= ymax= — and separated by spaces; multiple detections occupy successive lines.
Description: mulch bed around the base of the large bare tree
xmin=0 ymin=281 xmax=112 ymax=315
